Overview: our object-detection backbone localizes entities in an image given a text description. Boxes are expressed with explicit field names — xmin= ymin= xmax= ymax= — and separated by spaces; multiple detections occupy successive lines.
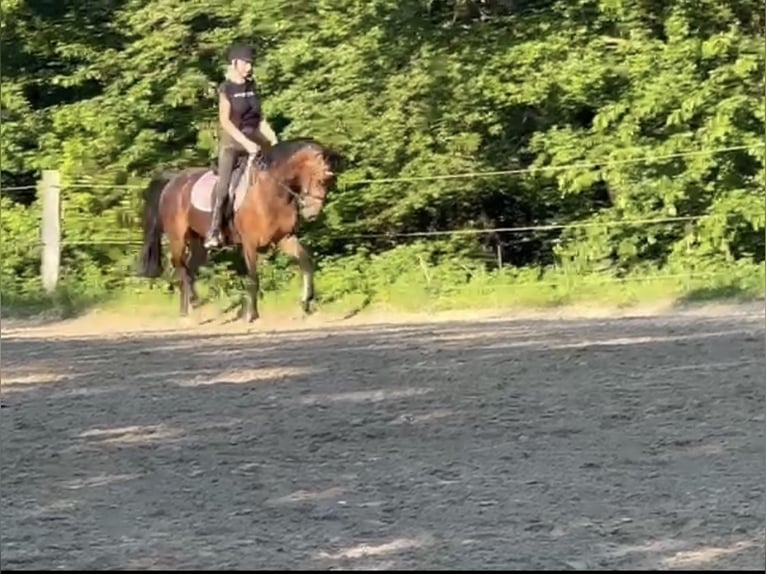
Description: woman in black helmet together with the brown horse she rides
xmin=139 ymin=41 xmax=341 ymax=321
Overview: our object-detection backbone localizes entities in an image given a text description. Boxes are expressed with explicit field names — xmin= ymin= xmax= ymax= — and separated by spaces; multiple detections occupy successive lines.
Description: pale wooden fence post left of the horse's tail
xmin=40 ymin=169 xmax=61 ymax=293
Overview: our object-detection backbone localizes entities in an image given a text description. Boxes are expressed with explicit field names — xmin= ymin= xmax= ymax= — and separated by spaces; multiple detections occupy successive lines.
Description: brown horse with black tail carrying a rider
xmin=140 ymin=139 xmax=340 ymax=322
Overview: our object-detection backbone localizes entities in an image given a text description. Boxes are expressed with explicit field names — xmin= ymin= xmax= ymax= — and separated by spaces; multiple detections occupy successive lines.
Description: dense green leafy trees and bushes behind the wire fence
xmin=0 ymin=0 xmax=766 ymax=316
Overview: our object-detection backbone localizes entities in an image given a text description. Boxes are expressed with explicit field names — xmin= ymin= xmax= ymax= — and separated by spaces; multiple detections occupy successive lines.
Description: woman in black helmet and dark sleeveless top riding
xmin=205 ymin=44 xmax=277 ymax=248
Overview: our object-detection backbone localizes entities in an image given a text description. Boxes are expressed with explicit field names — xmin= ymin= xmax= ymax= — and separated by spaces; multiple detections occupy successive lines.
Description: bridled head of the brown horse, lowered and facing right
xmin=269 ymin=139 xmax=340 ymax=221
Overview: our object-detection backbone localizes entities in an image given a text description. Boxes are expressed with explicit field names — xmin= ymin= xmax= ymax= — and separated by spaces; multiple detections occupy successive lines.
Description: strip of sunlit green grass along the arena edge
xmin=2 ymin=264 xmax=766 ymax=328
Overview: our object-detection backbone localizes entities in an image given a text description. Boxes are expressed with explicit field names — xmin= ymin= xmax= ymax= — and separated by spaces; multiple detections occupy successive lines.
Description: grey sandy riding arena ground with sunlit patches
xmin=0 ymin=303 xmax=766 ymax=569
